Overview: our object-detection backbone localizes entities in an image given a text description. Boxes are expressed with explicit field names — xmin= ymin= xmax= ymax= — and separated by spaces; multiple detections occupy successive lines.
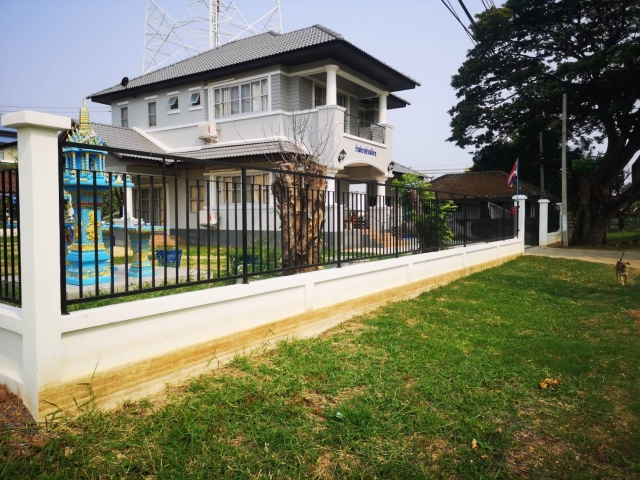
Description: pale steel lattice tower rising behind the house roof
xmin=142 ymin=0 xmax=282 ymax=74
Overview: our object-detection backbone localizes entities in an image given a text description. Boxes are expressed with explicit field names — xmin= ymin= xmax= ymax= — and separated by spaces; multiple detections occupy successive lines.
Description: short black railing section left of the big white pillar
xmin=0 ymin=169 xmax=22 ymax=306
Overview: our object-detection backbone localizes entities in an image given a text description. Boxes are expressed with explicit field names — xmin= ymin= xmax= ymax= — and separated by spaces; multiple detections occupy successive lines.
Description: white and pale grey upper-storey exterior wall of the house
xmin=111 ymin=59 xmax=400 ymax=173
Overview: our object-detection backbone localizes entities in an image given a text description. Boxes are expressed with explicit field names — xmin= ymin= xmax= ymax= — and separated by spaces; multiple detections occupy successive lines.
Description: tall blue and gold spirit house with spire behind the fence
xmin=63 ymin=101 xmax=133 ymax=285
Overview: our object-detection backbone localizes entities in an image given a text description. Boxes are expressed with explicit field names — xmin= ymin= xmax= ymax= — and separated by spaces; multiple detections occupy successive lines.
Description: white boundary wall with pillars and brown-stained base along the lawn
xmin=0 ymin=112 xmax=526 ymax=421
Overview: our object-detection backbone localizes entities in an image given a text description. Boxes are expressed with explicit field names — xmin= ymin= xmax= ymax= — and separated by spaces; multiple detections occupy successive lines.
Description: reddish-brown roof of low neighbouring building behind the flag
xmin=431 ymin=171 xmax=541 ymax=198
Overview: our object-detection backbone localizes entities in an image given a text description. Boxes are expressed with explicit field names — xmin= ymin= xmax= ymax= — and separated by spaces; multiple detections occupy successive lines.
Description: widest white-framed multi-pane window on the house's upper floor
xmin=213 ymin=78 xmax=269 ymax=118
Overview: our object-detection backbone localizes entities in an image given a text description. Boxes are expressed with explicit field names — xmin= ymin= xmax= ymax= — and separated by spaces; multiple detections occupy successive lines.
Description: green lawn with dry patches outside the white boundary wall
xmin=0 ymin=257 xmax=640 ymax=479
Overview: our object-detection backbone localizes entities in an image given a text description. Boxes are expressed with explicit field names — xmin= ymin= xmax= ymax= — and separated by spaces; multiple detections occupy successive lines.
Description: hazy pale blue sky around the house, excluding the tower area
xmin=0 ymin=0 xmax=483 ymax=174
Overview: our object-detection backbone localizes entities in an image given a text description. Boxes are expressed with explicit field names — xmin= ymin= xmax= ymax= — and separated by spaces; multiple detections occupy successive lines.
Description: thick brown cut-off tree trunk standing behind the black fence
xmin=271 ymin=160 xmax=327 ymax=275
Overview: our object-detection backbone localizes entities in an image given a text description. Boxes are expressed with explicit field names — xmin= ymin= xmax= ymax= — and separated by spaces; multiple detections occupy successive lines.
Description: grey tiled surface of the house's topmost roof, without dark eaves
xmin=87 ymin=25 xmax=419 ymax=98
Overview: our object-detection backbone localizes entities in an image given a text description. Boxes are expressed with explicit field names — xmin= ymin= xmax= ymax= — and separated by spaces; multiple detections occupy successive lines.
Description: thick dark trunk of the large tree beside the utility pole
xmin=571 ymin=177 xmax=618 ymax=246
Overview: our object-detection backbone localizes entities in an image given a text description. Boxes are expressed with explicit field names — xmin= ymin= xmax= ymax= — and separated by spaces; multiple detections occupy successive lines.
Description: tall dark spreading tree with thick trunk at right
xmin=449 ymin=0 xmax=640 ymax=245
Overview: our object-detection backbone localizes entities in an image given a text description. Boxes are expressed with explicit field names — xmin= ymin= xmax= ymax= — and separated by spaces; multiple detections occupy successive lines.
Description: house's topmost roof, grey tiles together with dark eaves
xmin=87 ymin=25 xmax=420 ymax=105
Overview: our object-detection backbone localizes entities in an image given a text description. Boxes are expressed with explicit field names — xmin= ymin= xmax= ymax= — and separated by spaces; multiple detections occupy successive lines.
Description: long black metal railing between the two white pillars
xmin=60 ymin=143 xmax=515 ymax=311
